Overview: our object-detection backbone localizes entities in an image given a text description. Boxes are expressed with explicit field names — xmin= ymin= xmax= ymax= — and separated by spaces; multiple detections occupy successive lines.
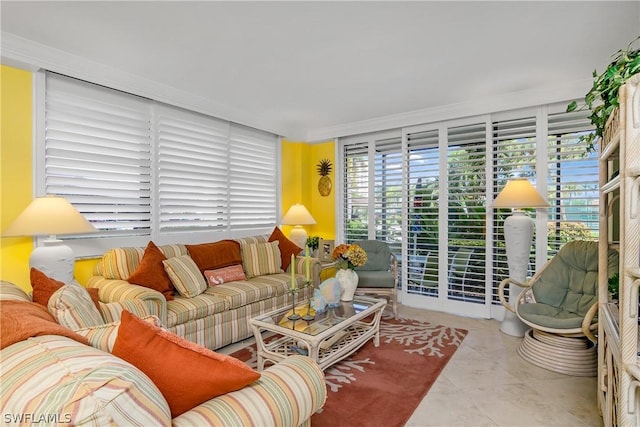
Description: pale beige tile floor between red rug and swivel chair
xmin=219 ymin=305 xmax=603 ymax=427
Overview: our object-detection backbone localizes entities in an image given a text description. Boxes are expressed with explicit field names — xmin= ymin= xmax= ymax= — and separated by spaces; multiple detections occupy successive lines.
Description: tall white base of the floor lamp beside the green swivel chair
xmin=500 ymin=209 xmax=533 ymax=337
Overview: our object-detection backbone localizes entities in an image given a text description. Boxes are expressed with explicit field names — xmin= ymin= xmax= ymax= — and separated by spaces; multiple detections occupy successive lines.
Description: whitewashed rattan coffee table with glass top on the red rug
xmin=250 ymin=296 xmax=387 ymax=371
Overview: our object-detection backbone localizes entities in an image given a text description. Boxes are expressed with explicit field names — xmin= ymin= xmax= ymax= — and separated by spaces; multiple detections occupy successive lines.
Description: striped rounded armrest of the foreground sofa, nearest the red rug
xmin=173 ymin=356 xmax=327 ymax=427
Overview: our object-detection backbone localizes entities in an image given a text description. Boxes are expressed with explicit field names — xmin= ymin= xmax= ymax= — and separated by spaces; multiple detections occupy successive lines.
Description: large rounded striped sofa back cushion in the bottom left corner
xmin=0 ymin=335 xmax=171 ymax=427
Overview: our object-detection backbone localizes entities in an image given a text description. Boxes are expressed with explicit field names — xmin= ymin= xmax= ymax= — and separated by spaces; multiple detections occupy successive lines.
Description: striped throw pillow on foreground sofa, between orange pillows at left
xmin=48 ymin=284 xmax=104 ymax=330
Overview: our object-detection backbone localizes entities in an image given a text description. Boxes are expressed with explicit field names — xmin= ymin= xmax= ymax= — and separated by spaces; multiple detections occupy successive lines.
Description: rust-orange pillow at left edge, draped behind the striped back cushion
xmin=0 ymin=301 xmax=89 ymax=349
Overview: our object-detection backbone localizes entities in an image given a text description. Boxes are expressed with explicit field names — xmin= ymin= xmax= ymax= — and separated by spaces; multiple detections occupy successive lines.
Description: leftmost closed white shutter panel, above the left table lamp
xmin=44 ymin=74 xmax=151 ymax=236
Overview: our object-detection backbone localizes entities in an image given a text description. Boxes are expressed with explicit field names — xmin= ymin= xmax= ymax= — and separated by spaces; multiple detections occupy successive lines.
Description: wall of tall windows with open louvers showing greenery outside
xmin=340 ymin=104 xmax=598 ymax=306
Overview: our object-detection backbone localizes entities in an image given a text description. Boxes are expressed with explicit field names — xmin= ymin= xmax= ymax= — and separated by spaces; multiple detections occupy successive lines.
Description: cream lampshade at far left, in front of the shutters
xmin=2 ymin=196 xmax=96 ymax=237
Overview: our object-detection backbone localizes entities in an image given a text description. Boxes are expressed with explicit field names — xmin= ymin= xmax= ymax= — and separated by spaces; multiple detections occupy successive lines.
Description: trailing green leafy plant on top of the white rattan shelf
xmin=567 ymin=37 xmax=640 ymax=152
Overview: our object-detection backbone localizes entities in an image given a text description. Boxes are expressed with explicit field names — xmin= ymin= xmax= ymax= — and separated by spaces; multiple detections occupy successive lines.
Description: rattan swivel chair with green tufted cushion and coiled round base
xmin=498 ymin=240 xmax=618 ymax=376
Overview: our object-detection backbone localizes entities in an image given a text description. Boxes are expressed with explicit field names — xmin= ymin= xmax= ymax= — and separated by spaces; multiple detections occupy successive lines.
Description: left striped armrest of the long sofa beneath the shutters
xmin=87 ymin=276 xmax=167 ymax=325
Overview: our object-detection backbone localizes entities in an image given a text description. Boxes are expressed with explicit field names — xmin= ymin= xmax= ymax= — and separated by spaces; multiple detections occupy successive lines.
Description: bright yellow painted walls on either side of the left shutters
xmin=0 ymin=65 xmax=335 ymax=291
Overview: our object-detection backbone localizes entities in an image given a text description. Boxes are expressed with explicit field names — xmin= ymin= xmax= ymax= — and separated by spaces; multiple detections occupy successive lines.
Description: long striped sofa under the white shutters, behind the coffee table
xmin=87 ymin=235 xmax=321 ymax=350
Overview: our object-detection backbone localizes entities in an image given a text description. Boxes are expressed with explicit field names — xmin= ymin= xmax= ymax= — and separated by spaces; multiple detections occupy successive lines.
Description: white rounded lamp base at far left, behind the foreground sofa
xmin=29 ymin=238 xmax=75 ymax=283
